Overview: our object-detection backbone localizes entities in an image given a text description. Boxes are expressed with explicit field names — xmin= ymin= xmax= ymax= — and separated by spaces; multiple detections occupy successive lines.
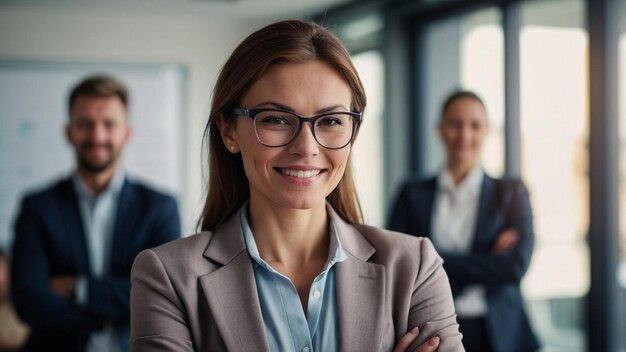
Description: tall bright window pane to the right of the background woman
xmin=520 ymin=0 xmax=590 ymax=351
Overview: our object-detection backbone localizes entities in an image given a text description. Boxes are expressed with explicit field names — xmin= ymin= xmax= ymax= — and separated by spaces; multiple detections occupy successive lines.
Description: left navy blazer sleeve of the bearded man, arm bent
xmin=11 ymin=198 xmax=102 ymax=332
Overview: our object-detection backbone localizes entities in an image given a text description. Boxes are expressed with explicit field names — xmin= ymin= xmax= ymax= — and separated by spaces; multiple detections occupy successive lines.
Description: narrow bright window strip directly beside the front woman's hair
xmin=352 ymin=50 xmax=385 ymax=226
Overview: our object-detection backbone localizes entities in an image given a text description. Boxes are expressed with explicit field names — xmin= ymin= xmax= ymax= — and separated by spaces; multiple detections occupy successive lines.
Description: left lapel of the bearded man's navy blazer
xmin=59 ymin=178 xmax=91 ymax=275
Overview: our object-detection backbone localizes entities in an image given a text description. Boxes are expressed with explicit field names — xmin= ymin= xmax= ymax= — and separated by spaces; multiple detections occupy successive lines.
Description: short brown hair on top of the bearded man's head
xmin=68 ymin=75 xmax=128 ymax=116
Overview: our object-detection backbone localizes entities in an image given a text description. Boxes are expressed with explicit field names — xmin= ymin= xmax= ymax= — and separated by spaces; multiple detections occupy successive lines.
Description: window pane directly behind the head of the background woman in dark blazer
xmin=419 ymin=8 xmax=504 ymax=177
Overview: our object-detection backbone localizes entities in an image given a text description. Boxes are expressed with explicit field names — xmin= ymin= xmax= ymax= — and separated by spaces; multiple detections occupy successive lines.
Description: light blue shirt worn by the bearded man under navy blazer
xmin=72 ymin=169 xmax=127 ymax=352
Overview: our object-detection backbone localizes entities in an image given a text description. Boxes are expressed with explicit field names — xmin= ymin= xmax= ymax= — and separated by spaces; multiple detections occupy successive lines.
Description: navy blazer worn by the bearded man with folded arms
xmin=11 ymin=179 xmax=181 ymax=351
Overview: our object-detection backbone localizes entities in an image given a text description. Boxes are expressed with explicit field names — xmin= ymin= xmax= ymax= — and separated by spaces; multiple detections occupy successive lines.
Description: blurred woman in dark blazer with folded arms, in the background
xmin=389 ymin=91 xmax=539 ymax=352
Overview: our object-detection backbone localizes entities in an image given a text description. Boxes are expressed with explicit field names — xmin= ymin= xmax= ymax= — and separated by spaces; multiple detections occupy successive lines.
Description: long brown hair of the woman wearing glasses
xmin=198 ymin=20 xmax=366 ymax=231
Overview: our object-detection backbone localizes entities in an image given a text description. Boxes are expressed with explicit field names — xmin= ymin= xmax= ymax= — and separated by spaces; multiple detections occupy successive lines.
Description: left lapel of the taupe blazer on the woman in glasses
xmin=198 ymin=212 xmax=269 ymax=351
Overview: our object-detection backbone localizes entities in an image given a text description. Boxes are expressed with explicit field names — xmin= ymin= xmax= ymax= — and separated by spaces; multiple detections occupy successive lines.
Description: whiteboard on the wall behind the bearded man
xmin=0 ymin=60 xmax=186 ymax=249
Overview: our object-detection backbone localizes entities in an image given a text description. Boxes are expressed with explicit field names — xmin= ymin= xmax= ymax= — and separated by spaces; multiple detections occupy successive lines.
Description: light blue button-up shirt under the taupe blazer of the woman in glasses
xmin=241 ymin=203 xmax=346 ymax=352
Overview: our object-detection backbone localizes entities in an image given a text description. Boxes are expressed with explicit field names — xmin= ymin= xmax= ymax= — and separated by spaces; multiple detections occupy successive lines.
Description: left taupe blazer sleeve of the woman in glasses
xmin=130 ymin=250 xmax=194 ymax=352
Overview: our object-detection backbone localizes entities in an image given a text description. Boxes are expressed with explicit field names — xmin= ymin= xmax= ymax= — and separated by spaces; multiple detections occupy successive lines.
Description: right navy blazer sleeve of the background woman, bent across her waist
xmin=442 ymin=182 xmax=534 ymax=287
